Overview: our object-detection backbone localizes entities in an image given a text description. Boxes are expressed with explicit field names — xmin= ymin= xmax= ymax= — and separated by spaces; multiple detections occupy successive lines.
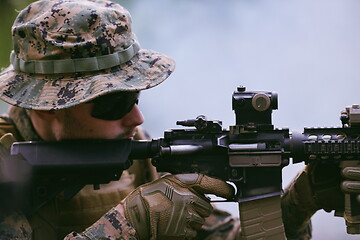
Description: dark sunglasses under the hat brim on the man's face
xmin=90 ymin=92 xmax=140 ymax=120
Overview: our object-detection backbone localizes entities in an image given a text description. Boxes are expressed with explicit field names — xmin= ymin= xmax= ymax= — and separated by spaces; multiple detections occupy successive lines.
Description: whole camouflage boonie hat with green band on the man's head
xmin=0 ymin=0 xmax=175 ymax=110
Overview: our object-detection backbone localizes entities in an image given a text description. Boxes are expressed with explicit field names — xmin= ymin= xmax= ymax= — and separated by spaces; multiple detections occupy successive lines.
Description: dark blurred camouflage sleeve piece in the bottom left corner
xmin=0 ymin=212 xmax=32 ymax=240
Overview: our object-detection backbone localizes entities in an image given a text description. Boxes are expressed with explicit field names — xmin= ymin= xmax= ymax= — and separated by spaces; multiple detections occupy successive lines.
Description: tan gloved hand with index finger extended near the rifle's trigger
xmin=121 ymin=173 xmax=234 ymax=239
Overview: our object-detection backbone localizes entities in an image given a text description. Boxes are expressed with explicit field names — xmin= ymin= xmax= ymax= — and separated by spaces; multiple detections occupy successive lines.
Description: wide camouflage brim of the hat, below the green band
xmin=0 ymin=49 xmax=175 ymax=110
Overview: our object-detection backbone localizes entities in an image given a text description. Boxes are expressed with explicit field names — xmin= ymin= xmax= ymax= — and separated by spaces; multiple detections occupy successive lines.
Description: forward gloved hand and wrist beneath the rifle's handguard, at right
xmin=281 ymin=161 xmax=360 ymax=237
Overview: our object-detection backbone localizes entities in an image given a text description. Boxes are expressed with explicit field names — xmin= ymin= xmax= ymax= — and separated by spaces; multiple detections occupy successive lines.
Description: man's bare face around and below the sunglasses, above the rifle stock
xmin=56 ymin=103 xmax=144 ymax=140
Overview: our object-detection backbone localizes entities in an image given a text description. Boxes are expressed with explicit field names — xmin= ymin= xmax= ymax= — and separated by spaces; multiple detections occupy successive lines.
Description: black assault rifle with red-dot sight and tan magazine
xmin=7 ymin=87 xmax=360 ymax=239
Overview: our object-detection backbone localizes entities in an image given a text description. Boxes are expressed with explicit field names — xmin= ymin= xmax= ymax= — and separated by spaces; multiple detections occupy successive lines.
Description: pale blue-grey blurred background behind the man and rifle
xmin=0 ymin=0 xmax=360 ymax=237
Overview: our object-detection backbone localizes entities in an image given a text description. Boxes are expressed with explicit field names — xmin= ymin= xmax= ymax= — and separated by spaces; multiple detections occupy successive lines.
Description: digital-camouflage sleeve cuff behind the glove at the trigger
xmin=64 ymin=208 xmax=136 ymax=240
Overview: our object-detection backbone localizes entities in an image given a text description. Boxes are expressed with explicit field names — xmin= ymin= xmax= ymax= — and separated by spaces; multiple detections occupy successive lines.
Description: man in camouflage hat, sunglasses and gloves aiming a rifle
xmin=0 ymin=0 xmax=358 ymax=239
